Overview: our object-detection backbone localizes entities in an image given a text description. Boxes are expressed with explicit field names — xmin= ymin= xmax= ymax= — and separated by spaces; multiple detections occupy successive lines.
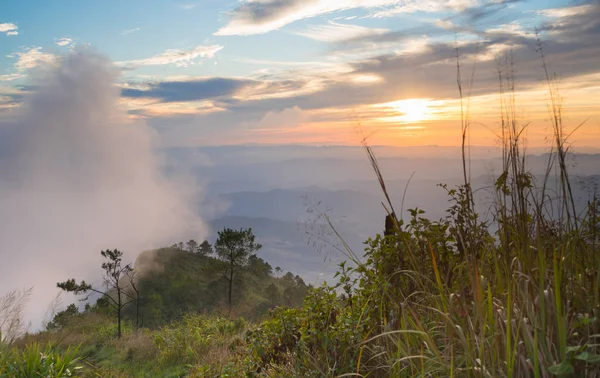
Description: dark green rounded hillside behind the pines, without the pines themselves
xmin=127 ymin=248 xmax=308 ymax=327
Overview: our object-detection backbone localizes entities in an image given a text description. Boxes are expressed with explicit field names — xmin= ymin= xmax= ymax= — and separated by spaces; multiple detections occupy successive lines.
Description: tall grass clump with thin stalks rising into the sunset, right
xmin=330 ymin=42 xmax=600 ymax=377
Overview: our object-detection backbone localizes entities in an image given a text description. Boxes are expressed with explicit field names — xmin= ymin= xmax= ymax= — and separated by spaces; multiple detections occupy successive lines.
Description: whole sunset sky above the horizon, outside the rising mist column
xmin=0 ymin=0 xmax=600 ymax=148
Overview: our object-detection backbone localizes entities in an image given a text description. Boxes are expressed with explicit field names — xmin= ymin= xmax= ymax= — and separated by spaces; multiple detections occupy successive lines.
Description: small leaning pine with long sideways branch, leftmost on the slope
xmin=56 ymin=249 xmax=135 ymax=338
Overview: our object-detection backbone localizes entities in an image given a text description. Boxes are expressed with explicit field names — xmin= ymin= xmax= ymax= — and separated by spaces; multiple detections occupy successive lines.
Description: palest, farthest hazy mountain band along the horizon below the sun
xmin=168 ymin=146 xmax=600 ymax=195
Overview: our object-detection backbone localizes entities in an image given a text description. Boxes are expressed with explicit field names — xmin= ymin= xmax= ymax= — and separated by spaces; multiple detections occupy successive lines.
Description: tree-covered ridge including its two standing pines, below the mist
xmin=51 ymin=228 xmax=309 ymax=338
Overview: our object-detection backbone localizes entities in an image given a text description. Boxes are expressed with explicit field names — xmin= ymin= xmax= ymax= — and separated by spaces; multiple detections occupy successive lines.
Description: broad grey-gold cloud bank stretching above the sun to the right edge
xmin=125 ymin=3 xmax=600 ymax=123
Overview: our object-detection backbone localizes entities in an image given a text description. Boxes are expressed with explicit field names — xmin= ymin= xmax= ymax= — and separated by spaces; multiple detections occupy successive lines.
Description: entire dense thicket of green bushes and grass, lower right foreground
xmin=243 ymin=125 xmax=600 ymax=377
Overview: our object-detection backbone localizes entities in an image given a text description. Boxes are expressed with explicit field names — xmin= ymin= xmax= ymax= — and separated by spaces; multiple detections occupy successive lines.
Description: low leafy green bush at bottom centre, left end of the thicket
xmin=247 ymin=285 xmax=364 ymax=377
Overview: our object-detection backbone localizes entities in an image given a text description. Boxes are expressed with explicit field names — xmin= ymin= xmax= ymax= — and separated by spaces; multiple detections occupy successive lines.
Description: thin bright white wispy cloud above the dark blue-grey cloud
xmin=116 ymin=45 xmax=223 ymax=68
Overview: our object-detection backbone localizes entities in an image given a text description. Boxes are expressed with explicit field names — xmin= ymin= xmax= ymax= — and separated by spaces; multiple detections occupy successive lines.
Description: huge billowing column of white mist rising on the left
xmin=0 ymin=50 xmax=206 ymax=327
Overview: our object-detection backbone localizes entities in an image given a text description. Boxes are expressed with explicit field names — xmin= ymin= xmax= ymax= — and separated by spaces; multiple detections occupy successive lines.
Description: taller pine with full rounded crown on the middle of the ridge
xmin=215 ymin=228 xmax=262 ymax=309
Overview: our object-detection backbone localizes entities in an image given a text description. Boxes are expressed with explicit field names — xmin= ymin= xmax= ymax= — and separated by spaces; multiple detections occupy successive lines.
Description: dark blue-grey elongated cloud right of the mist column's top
xmin=121 ymin=77 xmax=253 ymax=102
